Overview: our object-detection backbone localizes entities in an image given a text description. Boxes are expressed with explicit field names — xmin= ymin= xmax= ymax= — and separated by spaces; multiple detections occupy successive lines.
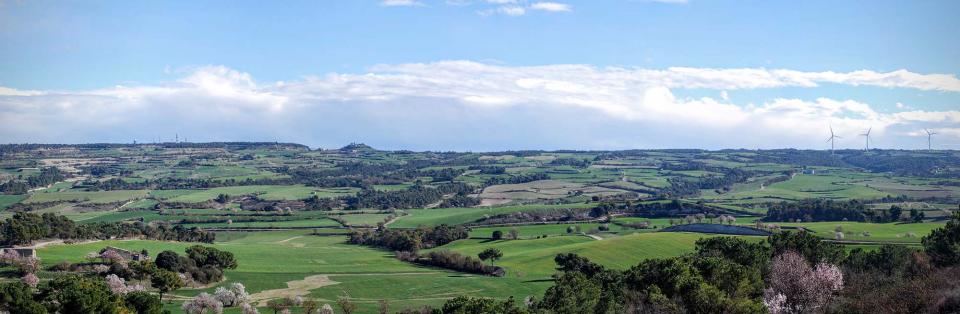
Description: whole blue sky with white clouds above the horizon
xmin=0 ymin=0 xmax=960 ymax=151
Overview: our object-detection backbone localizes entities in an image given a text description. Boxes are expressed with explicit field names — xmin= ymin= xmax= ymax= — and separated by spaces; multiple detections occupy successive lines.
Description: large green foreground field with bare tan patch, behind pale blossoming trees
xmin=39 ymin=231 xmax=550 ymax=313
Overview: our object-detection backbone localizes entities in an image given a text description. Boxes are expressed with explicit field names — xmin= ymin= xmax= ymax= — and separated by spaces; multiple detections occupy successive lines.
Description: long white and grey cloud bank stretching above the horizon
xmin=0 ymin=61 xmax=960 ymax=150
